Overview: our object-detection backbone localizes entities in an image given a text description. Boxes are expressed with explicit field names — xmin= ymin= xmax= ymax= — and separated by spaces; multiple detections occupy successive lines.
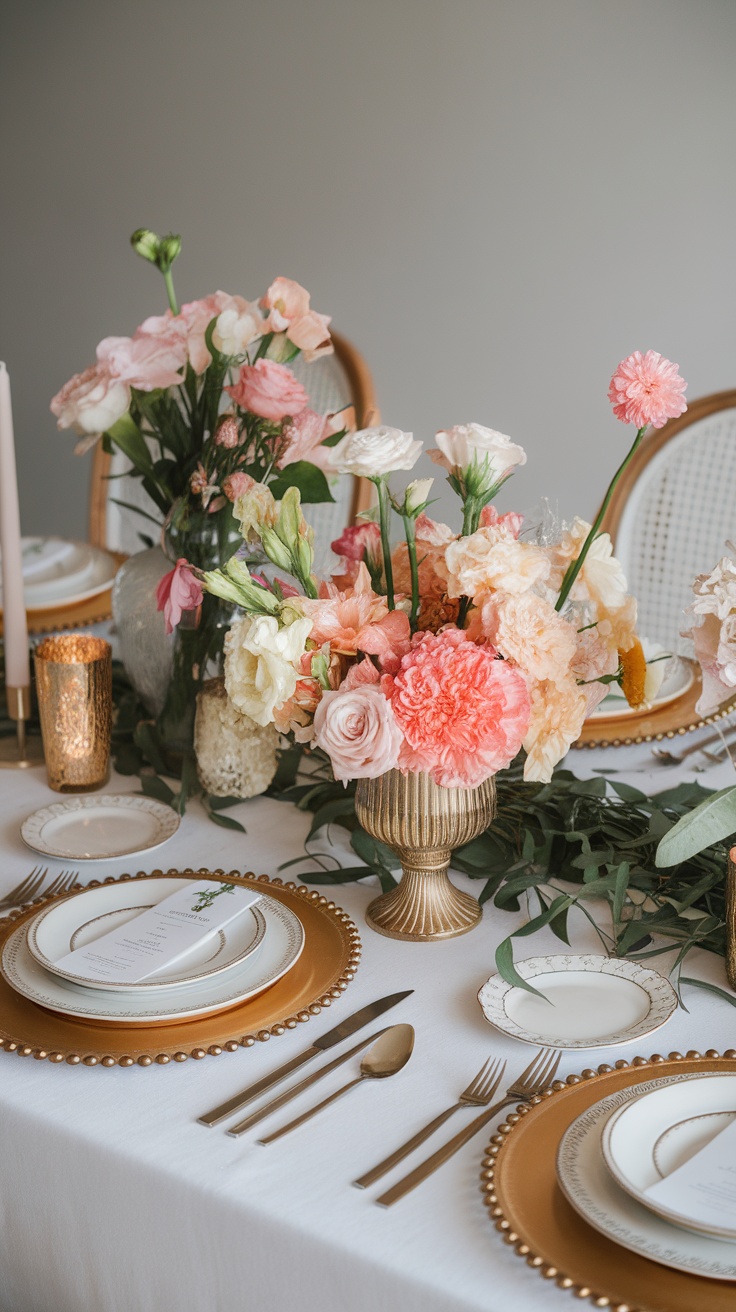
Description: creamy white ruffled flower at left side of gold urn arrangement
xmin=224 ymin=615 xmax=312 ymax=726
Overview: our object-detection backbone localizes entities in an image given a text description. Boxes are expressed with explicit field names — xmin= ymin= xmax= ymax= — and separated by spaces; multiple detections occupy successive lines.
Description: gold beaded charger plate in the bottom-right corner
xmin=481 ymin=1048 xmax=736 ymax=1312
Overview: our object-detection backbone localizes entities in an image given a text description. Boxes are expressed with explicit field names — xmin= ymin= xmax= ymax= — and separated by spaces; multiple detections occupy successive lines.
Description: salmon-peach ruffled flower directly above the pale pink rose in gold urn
xmin=299 ymin=562 xmax=409 ymax=668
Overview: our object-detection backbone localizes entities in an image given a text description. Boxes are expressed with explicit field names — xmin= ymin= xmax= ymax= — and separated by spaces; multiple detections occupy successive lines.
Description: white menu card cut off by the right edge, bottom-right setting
xmin=647 ymin=1119 xmax=736 ymax=1228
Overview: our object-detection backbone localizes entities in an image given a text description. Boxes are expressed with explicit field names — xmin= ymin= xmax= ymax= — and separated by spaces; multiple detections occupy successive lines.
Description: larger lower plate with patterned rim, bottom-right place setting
xmin=558 ymin=1076 xmax=736 ymax=1280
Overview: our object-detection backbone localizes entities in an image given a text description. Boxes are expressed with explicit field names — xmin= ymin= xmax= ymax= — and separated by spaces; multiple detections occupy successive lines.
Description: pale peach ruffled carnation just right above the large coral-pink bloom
xmin=474 ymin=592 xmax=577 ymax=681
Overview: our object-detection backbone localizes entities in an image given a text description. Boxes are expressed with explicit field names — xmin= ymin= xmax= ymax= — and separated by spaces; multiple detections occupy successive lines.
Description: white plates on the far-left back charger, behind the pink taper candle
xmin=0 ymin=538 xmax=117 ymax=610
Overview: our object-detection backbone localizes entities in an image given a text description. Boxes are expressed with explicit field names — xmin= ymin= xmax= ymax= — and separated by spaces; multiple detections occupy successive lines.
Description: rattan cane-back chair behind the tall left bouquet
xmin=89 ymin=333 xmax=379 ymax=572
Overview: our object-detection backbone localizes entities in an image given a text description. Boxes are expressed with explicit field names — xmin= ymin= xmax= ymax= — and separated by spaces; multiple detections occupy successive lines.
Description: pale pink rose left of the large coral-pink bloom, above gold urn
xmin=309 ymin=684 xmax=401 ymax=783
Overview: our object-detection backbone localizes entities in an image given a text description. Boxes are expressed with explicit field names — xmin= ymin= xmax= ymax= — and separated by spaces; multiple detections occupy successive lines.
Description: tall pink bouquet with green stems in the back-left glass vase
xmin=51 ymin=230 xmax=346 ymax=745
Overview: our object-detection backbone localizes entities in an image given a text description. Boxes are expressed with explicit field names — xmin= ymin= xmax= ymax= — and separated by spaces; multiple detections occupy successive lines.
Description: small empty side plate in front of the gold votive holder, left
xmin=21 ymin=792 xmax=180 ymax=861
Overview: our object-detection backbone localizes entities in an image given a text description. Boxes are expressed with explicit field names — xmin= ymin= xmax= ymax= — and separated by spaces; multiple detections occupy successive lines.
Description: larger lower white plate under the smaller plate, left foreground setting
xmin=0 ymin=897 xmax=304 ymax=1025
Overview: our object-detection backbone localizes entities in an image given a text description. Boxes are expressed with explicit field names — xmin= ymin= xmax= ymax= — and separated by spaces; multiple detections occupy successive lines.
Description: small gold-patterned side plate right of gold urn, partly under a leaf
xmin=478 ymin=954 xmax=677 ymax=1048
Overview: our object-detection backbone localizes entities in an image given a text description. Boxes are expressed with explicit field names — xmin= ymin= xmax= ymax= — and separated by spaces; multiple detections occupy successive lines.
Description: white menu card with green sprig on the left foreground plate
xmin=55 ymin=879 xmax=261 ymax=984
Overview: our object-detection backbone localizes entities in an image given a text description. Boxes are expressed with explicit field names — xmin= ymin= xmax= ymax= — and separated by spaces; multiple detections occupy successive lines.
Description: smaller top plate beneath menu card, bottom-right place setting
xmin=601 ymin=1072 xmax=736 ymax=1241
